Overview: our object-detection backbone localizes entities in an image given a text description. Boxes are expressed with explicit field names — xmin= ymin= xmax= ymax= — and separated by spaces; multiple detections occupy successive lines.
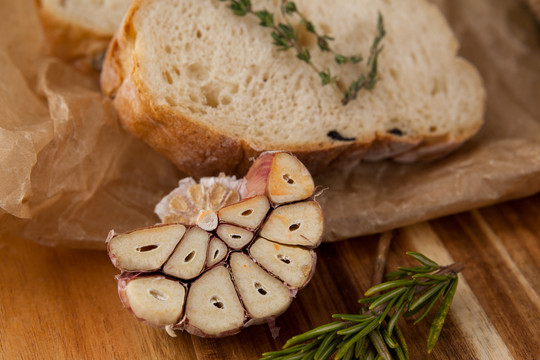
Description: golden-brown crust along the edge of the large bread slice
xmin=101 ymin=0 xmax=485 ymax=178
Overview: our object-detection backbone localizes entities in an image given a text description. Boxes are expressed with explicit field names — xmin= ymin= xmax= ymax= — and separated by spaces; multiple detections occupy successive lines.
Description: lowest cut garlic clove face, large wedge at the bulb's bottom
xmin=185 ymin=266 xmax=245 ymax=336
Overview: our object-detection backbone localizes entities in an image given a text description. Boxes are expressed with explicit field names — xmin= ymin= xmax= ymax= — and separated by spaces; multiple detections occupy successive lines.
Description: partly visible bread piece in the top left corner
xmin=36 ymin=0 xmax=131 ymax=66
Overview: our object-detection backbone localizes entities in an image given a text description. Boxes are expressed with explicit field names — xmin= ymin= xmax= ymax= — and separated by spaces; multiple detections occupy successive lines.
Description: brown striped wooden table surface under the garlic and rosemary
xmin=0 ymin=194 xmax=540 ymax=360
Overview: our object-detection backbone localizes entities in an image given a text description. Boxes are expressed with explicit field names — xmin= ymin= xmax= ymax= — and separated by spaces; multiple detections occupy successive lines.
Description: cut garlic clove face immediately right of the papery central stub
xmin=218 ymin=195 xmax=270 ymax=230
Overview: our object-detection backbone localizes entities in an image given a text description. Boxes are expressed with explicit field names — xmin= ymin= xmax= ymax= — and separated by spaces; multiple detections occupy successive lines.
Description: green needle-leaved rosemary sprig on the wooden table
xmin=262 ymin=252 xmax=463 ymax=360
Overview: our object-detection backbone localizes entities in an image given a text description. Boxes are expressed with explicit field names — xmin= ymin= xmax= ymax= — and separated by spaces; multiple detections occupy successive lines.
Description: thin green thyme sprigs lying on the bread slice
xmin=220 ymin=0 xmax=386 ymax=105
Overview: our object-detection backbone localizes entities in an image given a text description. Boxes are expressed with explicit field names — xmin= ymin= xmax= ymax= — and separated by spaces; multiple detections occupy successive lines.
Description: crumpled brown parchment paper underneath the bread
xmin=0 ymin=0 xmax=540 ymax=248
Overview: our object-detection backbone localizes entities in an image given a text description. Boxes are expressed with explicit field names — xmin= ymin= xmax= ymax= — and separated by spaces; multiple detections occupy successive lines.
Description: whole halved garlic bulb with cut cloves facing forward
xmin=107 ymin=152 xmax=323 ymax=337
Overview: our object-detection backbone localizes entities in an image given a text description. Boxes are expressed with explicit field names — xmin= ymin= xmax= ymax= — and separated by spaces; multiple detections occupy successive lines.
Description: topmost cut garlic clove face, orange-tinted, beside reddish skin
xmin=266 ymin=153 xmax=315 ymax=204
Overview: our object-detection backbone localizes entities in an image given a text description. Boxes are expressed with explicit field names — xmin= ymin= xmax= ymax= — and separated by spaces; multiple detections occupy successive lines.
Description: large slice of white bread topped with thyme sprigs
xmin=101 ymin=0 xmax=485 ymax=177
